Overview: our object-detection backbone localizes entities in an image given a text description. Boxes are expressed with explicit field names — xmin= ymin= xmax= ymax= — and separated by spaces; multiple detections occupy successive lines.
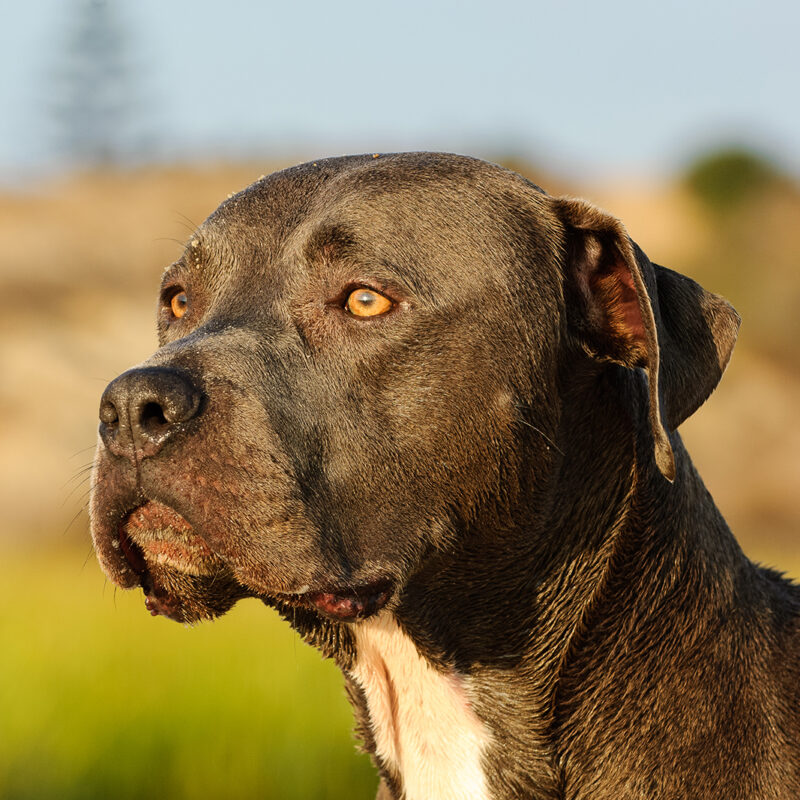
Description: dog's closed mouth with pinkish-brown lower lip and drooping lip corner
xmin=116 ymin=500 xmax=393 ymax=622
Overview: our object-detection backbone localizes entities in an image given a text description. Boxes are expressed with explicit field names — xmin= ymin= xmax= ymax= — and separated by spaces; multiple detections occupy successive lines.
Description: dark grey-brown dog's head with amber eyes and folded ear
xmin=91 ymin=154 xmax=737 ymax=632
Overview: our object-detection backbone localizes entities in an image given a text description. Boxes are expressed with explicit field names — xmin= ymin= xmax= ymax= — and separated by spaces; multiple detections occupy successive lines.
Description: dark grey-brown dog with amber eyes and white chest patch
xmin=91 ymin=153 xmax=800 ymax=800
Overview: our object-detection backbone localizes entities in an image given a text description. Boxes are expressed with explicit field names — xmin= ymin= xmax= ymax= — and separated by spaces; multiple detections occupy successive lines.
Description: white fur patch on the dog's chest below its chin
xmin=351 ymin=614 xmax=490 ymax=800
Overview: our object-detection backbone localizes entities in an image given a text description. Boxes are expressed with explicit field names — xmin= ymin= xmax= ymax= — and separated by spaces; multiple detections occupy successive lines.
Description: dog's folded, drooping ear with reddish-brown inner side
xmin=553 ymin=198 xmax=740 ymax=481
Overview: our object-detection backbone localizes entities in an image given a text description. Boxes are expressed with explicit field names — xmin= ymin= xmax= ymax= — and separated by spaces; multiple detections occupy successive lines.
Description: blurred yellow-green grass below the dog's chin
xmin=0 ymin=552 xmax=377 ymax=800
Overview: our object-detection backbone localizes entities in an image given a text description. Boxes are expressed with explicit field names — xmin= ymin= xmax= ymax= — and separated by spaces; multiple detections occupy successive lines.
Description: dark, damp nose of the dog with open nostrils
xmin=100 ymin=367 xmax=201 ymax=459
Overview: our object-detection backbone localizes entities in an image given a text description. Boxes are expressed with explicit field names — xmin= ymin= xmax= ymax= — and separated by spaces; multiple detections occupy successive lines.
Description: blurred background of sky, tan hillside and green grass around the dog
xmin=0 ymin=0 xmax=800 ymax=800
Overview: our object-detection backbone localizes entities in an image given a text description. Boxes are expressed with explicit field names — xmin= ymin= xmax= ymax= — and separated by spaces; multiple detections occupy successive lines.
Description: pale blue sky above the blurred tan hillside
xmin=0 ymin=0 xmax=800 ymax=183
